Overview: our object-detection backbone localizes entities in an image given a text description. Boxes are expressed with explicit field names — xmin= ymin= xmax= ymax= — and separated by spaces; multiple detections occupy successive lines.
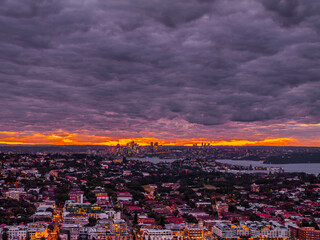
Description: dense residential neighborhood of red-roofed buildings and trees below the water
xmin=0 ymin=146 xmax=320 ymax=240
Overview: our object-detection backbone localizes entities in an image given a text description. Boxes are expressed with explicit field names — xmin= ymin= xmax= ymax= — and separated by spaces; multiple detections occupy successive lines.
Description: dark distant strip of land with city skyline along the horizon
xmin=0 ymin=141 xmax=320 ymax=164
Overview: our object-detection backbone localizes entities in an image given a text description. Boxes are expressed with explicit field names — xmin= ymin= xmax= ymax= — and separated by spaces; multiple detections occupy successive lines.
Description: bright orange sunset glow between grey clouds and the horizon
xmin=0 ymin=130 xmax=320 ymax=147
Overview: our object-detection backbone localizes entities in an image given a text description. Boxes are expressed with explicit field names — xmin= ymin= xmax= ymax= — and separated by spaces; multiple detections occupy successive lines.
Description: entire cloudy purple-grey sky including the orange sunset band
xmin=0 ymin=0 xmax=320 ymax=146
